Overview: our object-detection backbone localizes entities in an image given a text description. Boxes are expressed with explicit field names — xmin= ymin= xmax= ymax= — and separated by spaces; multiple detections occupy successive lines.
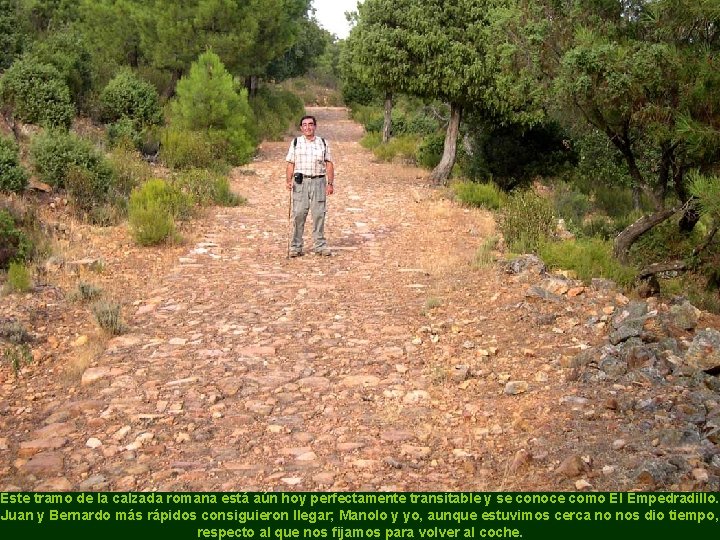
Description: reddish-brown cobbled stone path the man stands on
xmin=0 ymin=108 xmax=716 ymax=491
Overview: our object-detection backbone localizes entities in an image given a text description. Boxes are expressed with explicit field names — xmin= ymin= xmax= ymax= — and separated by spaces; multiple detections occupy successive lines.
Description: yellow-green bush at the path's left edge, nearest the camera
xmin=128 ymin=179 xmax=192 ymax=246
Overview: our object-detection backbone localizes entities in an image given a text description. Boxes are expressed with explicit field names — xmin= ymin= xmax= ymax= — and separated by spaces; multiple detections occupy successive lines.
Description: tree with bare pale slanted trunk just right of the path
xmin=353 ymin=0 xmax=542 ymax=182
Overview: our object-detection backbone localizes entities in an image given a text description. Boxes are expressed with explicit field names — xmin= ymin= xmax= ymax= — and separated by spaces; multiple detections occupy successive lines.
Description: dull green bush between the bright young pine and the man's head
xmin=250 ymin=86 xmax=304 ymax=141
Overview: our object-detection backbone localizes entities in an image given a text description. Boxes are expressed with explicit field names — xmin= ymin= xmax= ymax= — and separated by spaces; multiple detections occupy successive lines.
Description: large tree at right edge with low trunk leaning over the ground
xmin=529 ymin=0 xmax=720 ymax=260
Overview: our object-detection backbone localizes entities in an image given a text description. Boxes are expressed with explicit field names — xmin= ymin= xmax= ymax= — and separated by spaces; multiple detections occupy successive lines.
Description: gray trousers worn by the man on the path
xmin=290 ymin=176 xmax=327 ymax=252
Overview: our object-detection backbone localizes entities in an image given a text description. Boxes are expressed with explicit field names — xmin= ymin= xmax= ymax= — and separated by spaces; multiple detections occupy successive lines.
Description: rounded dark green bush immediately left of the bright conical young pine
xmin=100 ymin=69 xmax=163 ymax=130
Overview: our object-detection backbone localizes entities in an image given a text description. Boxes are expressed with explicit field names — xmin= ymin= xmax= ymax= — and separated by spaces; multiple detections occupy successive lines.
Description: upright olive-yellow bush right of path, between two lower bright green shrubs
xmin=499 ymin=189 xmax=555 ymax=253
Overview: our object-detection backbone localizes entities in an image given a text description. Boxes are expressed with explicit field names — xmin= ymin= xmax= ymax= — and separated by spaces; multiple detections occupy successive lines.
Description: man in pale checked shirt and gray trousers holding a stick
xmin=285 ymin=116 xmax=335 ymax=257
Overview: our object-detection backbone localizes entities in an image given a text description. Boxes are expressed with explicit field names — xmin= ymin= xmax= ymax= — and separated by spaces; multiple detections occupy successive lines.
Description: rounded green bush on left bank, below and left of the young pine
xmin=30 ymin=130 xmax=112 ymax=190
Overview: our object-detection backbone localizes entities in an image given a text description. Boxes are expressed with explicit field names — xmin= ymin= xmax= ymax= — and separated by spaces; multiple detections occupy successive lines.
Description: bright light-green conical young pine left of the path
xmin=171 ymin=52 xmax=255 ymax=165
